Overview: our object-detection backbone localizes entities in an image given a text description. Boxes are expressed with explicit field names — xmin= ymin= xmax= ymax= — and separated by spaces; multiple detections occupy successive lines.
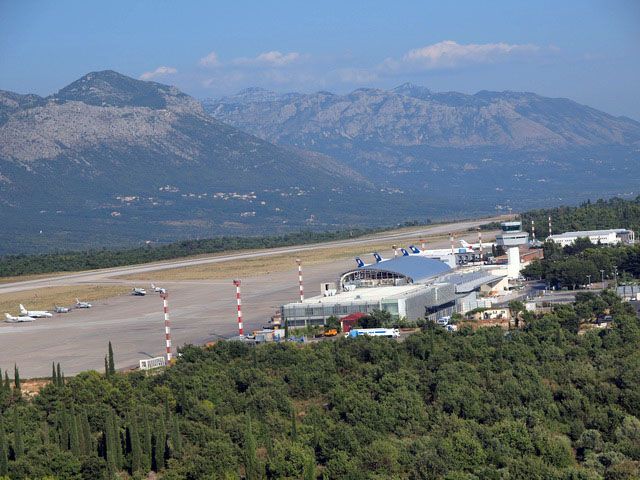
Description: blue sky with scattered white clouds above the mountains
xmin=0 ymin=0 xmax=640 ymax=121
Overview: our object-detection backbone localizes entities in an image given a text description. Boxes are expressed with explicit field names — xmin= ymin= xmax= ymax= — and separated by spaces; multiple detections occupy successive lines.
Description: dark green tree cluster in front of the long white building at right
xmin=522 ymin=238 xmax=640 ymax=289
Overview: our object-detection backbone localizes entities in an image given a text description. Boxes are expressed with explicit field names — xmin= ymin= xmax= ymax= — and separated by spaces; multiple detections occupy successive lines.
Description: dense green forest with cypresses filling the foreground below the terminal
xmin=0 ymin=290 xmax=640 ymax=480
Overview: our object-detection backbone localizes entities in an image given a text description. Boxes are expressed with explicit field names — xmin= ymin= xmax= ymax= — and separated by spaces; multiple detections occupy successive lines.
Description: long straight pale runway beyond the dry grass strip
xmin=0 ymin=217 xmax=503 ymax=295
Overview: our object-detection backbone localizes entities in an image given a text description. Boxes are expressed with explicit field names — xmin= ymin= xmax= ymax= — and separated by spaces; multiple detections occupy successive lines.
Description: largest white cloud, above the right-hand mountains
xmin=383 ymin=40 xmax=540 ymax=70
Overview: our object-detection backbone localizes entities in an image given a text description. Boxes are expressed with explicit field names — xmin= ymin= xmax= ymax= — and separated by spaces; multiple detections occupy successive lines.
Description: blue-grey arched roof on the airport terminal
xmin=340 ymin=255 xmax=451 ymax=286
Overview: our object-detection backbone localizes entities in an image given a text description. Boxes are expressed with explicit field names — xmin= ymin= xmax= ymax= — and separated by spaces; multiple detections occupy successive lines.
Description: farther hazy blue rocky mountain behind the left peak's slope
xmin=202 ymin=83 xmax=640 ymax=218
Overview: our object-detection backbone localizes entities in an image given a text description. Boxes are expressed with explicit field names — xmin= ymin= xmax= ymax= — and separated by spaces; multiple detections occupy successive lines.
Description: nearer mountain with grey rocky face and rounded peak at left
xmin=0 ymin=71 xmax=420 ymax=254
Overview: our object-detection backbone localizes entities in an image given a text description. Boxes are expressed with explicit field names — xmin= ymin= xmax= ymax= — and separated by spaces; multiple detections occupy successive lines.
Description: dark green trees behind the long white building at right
xmin=520 ymin=196 xmax=640 ymax=240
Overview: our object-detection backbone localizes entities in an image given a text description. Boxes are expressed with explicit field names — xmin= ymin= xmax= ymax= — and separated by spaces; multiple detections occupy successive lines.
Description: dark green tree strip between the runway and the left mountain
xmin=0 ymin=222 xmax=430 ymax=277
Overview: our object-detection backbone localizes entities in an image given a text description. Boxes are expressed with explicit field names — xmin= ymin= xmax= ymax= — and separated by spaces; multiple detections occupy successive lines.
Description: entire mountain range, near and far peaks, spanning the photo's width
xmin=0 ymin=71 xmax=640 ymax=254
